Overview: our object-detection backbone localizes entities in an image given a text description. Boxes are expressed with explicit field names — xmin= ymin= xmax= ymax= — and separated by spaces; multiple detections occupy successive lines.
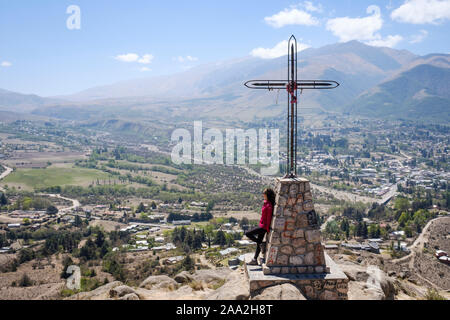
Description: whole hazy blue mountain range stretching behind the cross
xmin=0 ymin=41 xmax=450 ymax=122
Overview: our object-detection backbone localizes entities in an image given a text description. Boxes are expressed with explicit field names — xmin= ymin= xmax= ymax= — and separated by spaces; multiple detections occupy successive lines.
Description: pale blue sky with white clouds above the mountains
xmin=0 ymin=0 xmax=450 ymax=96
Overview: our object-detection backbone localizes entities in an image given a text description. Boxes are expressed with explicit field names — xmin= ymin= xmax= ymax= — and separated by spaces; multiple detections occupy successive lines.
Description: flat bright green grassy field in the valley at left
xmin=1 ymin=164 xmax=109 ymax=190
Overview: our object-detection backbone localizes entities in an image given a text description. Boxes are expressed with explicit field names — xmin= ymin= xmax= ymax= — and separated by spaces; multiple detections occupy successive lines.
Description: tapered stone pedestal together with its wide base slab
xmin=245 ymin=177 xmax=348 ymax=300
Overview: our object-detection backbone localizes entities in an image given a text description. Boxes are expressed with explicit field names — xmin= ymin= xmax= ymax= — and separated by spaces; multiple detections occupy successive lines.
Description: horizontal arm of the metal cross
xmin=244 ymin=80 xmax=339 ymax=90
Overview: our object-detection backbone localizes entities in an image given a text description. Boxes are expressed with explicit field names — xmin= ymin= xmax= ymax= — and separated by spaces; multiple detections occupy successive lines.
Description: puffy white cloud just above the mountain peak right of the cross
xmin=326 ymin=5 xmax=383 ymax=42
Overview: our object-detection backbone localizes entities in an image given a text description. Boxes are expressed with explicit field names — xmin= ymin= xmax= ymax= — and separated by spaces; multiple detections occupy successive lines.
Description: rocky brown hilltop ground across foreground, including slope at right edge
xmin=0 ymin=218 xmax=450 ymax=300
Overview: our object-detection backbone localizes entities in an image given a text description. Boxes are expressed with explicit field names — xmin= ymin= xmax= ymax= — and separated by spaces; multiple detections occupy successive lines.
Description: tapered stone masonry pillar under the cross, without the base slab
xmin=263 ymin=178 xmax=329 ymax=274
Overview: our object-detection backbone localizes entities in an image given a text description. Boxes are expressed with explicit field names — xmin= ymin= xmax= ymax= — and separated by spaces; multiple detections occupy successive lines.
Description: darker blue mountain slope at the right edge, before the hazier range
xmin=347 ymin=55 xmax=450 ymax=122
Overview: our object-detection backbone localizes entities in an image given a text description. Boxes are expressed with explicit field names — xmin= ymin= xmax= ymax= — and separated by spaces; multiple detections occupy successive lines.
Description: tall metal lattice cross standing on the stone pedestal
xmin=245 ymin=35 xmax=339 ymax=178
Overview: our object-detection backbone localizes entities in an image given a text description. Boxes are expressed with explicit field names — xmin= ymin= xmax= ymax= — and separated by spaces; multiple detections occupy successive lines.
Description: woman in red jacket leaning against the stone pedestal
xmin=245 ymin=188 xmax=275 ymax=265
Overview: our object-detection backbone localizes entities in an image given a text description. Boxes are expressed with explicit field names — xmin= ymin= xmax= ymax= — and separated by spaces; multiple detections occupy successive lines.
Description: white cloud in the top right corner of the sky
xmin=391 ymin=0 xmax=450 ymax=24
